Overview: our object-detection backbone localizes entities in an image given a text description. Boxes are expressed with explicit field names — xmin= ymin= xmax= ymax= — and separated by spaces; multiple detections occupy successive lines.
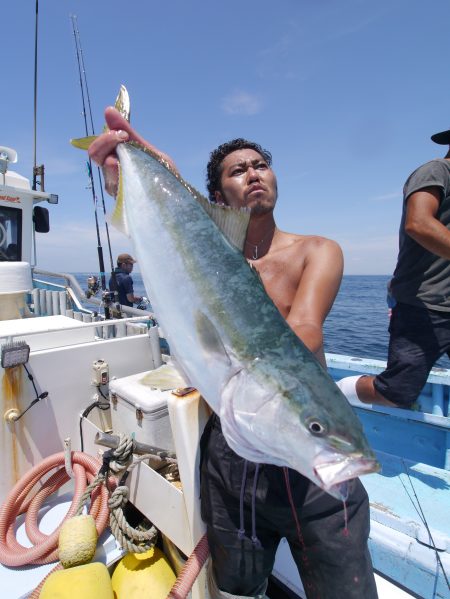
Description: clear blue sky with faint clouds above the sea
xmin=0 ymin=0 xmax=450 ymax=274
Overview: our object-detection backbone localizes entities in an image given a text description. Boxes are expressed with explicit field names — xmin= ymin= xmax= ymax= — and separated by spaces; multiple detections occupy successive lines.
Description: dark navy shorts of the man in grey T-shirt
xmin=374 ymin=303 xmax=450 ymax=408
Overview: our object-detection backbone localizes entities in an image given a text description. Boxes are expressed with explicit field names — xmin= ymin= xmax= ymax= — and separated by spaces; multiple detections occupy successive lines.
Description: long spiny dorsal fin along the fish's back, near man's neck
xmin=127 ymin=141 xmax=250 ymax=252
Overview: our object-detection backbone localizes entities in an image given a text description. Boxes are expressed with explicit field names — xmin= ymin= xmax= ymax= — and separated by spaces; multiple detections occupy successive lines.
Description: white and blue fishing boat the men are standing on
xmin=0 ymin=10 xmax=450 ymax=599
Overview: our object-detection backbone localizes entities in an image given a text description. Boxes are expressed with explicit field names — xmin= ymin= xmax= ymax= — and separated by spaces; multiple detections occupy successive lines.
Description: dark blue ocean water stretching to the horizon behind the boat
xmin=73 ymin=273 xmax=450 ymax=368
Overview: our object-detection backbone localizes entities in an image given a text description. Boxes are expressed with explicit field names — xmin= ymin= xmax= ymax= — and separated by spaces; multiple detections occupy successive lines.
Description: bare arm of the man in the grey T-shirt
xmin=405 ymin=187 xmax=450 ymax=260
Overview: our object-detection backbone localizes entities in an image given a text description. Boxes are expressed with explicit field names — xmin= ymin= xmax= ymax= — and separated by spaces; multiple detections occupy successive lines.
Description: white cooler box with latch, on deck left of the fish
xmin=109 ymin=371 xmax=175 ymax=451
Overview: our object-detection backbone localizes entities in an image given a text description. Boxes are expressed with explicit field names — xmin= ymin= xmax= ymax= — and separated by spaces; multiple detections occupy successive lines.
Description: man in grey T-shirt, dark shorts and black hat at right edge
xmin=338 ymin=130 xmax=450 ymax=408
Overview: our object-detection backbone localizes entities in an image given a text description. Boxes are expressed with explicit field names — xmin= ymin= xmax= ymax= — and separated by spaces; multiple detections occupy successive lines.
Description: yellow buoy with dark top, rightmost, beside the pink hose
xmin=112 ymin=547 xmax=176 ymax=599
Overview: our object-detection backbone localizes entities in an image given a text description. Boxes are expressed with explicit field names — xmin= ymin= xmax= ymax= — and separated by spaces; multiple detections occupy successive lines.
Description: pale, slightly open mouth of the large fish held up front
xmin=314 ymin=452 xmax=381 ymax=499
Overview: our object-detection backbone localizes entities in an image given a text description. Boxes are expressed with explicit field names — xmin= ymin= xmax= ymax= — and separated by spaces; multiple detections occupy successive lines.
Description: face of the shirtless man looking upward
xmin=215 ymin=148 xmax=277 ymax=214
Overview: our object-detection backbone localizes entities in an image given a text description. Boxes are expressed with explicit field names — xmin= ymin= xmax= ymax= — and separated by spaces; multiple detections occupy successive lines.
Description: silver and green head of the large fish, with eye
xmin=221 ymin=369 xmax=379 ymax=499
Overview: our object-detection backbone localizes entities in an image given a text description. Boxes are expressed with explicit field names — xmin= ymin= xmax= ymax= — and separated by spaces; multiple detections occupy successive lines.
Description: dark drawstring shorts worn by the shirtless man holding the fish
xmin=200 ymin=415 xmax=377 ymax=599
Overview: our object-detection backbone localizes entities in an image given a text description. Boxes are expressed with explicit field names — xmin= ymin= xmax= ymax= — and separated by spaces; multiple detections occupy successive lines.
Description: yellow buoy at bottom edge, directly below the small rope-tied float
xmin=39 ymin=562 xmax=114 ymax=599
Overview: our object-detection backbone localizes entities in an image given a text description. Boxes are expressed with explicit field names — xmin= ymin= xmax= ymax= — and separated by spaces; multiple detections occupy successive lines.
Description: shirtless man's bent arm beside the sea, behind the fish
xmin=286 ymin=237 xmax=344 ymax=367
